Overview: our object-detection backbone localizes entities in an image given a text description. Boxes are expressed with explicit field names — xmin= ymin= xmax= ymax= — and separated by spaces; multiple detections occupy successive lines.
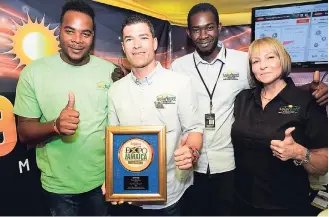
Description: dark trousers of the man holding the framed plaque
xmin=113 ymin=200 xmax=181 ymax=216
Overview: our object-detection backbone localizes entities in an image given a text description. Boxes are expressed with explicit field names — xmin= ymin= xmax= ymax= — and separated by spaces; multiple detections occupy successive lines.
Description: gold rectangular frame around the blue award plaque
xmin=105 ymin=126 xmax=167 ymax=202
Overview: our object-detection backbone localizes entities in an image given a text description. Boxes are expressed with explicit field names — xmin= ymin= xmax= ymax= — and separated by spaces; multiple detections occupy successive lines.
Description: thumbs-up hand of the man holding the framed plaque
xmin=174 ymin=134 xmax=194 ymax=170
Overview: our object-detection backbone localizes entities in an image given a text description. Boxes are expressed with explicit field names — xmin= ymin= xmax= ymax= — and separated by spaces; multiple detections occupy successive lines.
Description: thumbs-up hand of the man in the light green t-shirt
xmin=56 ymin=92 xmax=80 ymax=136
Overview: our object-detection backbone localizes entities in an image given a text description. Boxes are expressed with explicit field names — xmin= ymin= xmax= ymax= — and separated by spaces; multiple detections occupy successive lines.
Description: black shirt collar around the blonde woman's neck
xmin=249 ymin=77 xmax=296 ymax=105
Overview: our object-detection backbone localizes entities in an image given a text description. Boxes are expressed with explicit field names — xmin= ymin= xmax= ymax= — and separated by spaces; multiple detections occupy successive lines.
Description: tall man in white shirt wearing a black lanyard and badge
xmin=171 ymin=3 xmax=249 ymax=215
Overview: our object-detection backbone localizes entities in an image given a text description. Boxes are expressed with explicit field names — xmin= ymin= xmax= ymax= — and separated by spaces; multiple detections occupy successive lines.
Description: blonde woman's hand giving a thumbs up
xmin=270 ymin=127 xmax=302 ymax=161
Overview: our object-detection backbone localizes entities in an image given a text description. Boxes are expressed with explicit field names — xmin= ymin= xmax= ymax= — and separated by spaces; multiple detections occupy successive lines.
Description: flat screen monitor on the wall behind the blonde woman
xmin=252 ymin=1 xmax=328 ymax=70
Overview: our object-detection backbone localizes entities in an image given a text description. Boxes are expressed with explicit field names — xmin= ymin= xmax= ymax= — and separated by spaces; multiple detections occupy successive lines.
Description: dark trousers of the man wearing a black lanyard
xmin=182 ymin=171 xmax=234 ymax=216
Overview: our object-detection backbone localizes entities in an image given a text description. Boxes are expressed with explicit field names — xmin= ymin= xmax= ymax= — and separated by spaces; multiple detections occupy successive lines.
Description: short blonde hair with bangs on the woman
xmin=248 ymin=37 xmax=291 ymax=82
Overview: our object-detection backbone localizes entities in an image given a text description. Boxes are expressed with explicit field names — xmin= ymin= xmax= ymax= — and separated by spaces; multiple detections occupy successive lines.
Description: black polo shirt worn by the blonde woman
xmin=231 ymin=78 xmax=328 ymax=209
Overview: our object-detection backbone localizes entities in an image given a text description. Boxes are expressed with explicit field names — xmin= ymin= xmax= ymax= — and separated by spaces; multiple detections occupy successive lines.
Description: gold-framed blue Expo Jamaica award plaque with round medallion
xmin=105 ymin=126 xmax=167 ymax=201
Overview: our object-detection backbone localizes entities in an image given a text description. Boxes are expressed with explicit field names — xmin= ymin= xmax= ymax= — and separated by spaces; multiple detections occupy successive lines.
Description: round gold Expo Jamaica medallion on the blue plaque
xmin=118 ymin=138 xmax=153 ymax=172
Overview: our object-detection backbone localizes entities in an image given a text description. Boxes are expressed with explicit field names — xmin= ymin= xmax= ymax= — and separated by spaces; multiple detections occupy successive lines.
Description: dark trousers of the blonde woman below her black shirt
xmin=233 ymin=196 xmax=314 ymax=216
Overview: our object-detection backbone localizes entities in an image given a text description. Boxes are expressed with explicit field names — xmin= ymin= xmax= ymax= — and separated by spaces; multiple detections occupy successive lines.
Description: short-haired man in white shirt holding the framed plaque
xmin=108 ymin=15 xmax=203 ymax=216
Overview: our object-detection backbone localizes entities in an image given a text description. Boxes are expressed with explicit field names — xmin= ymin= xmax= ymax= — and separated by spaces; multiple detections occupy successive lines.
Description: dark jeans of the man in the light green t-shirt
xmin=44 ymin=186 xmax=109 ymax=216
